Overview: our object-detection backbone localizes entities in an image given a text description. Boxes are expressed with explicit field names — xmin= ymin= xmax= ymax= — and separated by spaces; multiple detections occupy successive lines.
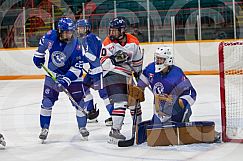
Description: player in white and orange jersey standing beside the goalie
xmin=101 ymin=17 xmax=143 ymax=143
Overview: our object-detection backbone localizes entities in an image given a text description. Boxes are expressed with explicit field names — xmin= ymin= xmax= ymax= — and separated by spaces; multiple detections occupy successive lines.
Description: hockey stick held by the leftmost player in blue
xmin=41 ymin=64 xmax=99 ymax=120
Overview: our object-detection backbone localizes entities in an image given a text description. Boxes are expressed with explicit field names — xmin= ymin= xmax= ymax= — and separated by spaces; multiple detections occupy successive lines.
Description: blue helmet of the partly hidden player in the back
xmin=76 ymin=19 xmax=91 ymax=37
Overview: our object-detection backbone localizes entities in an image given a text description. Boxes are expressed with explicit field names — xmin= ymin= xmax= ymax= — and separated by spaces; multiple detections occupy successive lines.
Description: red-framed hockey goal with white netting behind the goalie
xmin=219 ymin=41 xmax=243 ymax=142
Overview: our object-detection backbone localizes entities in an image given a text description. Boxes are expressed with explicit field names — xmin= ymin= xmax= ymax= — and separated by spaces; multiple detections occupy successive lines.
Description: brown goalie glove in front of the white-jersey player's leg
xmin=127 ymin=84 xmax=145 ymax=107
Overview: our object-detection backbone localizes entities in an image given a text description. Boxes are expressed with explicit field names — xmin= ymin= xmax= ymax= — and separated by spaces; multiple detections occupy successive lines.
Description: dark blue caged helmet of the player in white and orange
xmin=109 ymin=17 xmax=127 ymax=41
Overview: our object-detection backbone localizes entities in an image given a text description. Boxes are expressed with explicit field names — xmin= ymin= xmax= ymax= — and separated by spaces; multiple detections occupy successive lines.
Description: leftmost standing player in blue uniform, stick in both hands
xmin=33 ymin=18 xmax=89 ymax=141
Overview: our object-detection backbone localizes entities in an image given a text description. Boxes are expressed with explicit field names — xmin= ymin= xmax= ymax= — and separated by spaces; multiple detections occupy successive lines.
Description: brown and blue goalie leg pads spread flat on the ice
xmin=136 ymin=120 xmax=215 ymax=146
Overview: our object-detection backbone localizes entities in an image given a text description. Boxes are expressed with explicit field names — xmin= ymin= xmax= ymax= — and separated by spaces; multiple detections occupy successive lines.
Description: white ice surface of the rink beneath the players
xmin=0 ymin=75 xmax=243 ymax=161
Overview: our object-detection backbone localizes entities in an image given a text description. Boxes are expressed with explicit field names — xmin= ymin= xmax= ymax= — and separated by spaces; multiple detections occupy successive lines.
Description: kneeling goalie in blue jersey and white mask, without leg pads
xmin=136 ymin=46 xmax=197 ymax=124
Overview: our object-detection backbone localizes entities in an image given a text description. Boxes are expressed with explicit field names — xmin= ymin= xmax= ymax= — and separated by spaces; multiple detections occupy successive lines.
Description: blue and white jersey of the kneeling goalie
xmin=138 ymin=62 xmax=197 ymax=109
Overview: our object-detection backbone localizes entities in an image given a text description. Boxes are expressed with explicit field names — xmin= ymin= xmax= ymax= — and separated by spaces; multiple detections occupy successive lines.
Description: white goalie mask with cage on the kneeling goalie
xmin=154 ymin=46 xmax=174 ymax=73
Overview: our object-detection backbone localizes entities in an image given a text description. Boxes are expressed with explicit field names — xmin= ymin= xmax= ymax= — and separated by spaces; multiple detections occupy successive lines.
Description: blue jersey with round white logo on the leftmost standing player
xmin=35 ymin=30 xmax=84 ymax=84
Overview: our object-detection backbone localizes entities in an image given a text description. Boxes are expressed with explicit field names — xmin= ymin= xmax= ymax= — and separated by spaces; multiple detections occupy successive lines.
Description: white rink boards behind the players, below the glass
xmin=0 ymin=42 xmax=219 ymax=76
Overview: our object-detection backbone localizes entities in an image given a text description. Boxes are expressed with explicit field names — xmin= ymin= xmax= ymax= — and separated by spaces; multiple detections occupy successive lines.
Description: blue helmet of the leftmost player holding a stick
xmin=57 ymin=17 xmax=75 ymax=31
